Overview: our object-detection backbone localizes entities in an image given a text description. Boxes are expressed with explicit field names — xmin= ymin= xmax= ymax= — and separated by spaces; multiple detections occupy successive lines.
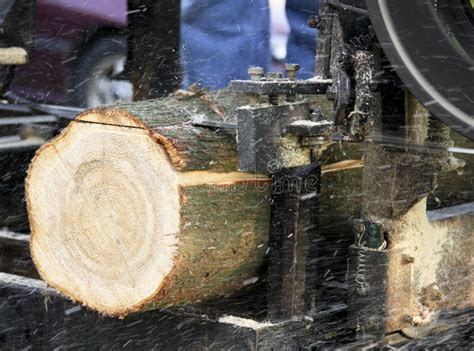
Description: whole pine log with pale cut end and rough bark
xmin=26 ymin=91 xmax=270 ymax=316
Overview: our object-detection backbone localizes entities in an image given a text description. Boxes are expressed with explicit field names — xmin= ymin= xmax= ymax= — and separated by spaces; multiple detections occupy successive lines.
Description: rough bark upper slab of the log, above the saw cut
xmin=77 ymin=90 xmax=247 ymax=172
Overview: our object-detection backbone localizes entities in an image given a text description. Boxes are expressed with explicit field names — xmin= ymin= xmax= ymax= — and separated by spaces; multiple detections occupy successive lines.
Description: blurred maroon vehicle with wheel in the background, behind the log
xmin=6 ymin=0 xmax=128 ymax=107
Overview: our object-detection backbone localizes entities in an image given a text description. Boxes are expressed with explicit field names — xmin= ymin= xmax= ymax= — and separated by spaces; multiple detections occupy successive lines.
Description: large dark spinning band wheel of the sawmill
xmin=367 ymin=0 xmax=474 ymax=140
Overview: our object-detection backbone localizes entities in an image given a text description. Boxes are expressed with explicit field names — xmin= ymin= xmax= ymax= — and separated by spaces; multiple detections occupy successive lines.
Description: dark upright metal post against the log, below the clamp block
xmin=268 ymin=163 xmax=321 ymax=321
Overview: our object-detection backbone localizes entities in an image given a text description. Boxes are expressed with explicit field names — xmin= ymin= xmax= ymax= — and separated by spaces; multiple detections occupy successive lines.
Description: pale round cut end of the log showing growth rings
xmin=28 ymin=111 xmax=180 ymax=315
